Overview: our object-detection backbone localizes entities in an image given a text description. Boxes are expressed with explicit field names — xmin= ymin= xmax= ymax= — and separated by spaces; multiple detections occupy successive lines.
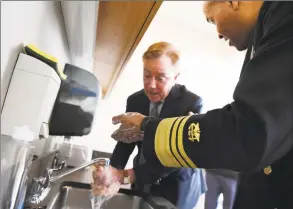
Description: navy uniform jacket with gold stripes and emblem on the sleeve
xmin=142 ymin=2 xmax=293 ymax=209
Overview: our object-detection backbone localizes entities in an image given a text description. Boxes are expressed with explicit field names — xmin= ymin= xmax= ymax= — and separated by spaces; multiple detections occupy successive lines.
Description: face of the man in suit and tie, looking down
xmin=143 ymin=56 xmax=178 ymax=102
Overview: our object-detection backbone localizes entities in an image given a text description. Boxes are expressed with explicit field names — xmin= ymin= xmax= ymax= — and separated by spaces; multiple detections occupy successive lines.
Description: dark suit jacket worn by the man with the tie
xmin=111 ymin=84 xmax=205 ymax=207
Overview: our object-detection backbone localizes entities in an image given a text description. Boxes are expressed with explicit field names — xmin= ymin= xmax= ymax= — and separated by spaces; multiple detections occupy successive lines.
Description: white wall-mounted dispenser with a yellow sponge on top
xmin=1 ymin=53 xmax=61 ymax=139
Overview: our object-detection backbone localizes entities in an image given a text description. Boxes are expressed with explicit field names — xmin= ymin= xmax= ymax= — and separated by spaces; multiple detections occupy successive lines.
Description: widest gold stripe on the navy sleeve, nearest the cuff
xmin=155 ymin=118 xmax=181 ymax=167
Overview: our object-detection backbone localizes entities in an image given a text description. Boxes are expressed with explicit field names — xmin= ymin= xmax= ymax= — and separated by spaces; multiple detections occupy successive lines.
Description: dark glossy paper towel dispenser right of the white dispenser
xmin=49 ymin=64 xmax=101 ymax=136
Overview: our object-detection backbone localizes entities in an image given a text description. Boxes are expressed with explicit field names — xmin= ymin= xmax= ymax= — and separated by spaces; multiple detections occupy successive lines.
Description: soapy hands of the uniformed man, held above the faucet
xmin=111 ymin=112 xmax=145 ymax=143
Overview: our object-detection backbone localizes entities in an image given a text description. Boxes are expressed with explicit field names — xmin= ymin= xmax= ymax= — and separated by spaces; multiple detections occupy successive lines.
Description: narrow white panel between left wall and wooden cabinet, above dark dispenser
xmin=61 ymin=1 xmax=99 ymax=72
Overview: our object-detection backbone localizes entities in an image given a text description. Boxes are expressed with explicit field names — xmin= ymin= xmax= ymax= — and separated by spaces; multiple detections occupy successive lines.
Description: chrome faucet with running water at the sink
xmin=26 ymin=152 xmax=110 ymax=207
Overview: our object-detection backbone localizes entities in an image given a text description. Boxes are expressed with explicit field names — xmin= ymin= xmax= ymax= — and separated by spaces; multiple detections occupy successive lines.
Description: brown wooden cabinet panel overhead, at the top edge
xmin=94 ymin=1 xmax=162 ymax=97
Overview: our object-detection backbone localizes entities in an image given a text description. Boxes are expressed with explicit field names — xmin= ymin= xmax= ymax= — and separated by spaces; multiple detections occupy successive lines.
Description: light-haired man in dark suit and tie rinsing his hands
xmin=93 ymin=42 xmax=206 ymax=209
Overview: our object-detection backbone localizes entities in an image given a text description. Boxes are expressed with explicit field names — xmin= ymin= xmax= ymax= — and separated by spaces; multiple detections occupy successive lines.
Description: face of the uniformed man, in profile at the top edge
xmin=204 ymin=1 xmax=256 ymax=51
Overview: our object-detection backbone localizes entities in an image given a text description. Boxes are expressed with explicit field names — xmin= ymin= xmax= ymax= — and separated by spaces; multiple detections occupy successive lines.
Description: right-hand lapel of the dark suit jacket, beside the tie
xmin=160 ymin=85 xmax=180 ymax=118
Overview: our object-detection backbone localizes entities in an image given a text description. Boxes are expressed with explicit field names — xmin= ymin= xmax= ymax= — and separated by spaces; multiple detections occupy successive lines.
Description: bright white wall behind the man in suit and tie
xmin=72 ymin=1 xmax=244 ymax=170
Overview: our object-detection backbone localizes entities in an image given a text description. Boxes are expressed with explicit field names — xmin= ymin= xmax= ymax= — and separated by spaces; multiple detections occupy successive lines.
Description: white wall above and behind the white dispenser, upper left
xmin=1 ymin=1 xmax=70 ymax=109
